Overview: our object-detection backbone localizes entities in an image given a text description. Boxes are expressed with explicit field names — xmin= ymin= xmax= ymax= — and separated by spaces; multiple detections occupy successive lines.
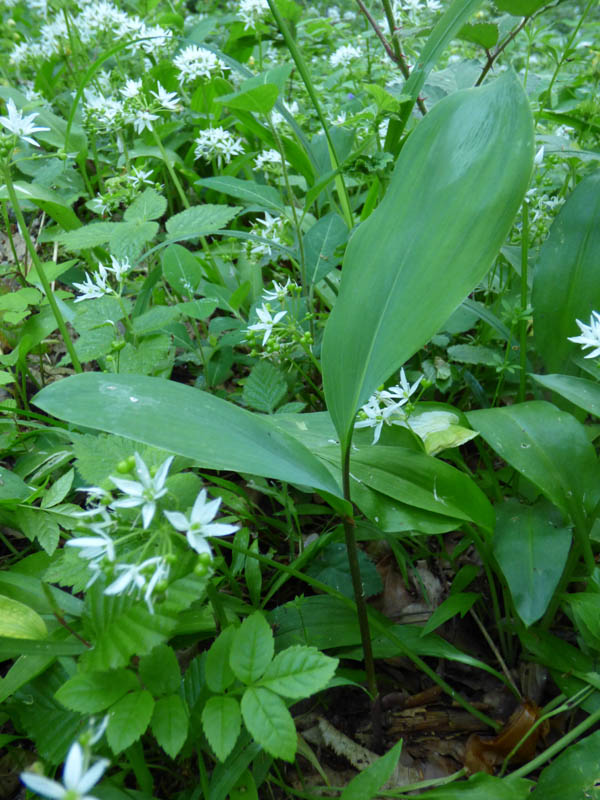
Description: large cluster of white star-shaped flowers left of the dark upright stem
xmin=67 ymin=453 xmax=239 ymax=613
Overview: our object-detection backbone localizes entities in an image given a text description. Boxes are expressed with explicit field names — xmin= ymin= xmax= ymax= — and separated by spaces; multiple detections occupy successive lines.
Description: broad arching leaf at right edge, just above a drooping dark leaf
xmin=467 ymin=401 xmax=600 ymax=515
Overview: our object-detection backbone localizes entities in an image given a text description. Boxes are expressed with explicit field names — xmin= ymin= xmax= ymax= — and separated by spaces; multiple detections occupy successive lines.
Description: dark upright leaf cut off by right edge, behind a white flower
xmin=532 ymin=171 xmax=600 ymax=372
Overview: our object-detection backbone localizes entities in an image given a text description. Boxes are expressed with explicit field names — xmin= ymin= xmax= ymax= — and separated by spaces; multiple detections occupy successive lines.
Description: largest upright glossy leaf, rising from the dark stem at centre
xmin=323 ymin=73 xmax=533 ymax=442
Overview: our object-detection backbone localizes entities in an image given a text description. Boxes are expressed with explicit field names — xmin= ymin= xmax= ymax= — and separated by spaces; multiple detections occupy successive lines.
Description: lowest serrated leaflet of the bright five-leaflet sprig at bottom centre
xmin=242 ymin=686 xmax=298 ymax=761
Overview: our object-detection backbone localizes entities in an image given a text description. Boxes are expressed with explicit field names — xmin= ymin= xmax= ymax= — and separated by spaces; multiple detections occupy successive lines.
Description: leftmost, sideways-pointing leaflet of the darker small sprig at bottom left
xmin=55 ymin=669 xmax=139 ymax=714
